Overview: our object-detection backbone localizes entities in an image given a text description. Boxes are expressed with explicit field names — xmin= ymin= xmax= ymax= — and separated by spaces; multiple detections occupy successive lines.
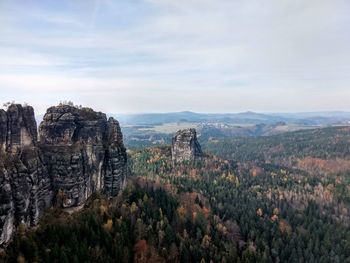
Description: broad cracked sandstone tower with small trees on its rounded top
xmin=39 ymin=105 xmax=126 ymax=207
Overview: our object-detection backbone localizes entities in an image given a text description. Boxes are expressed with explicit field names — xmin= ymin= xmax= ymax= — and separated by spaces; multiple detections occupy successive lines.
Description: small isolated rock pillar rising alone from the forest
xmin=171 ymin=129 xmax=203 ymax=163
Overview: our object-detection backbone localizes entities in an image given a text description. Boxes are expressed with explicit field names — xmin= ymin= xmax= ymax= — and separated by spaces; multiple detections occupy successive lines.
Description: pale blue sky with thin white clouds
xmin=0 ymin=0 xmax=350 ymax=114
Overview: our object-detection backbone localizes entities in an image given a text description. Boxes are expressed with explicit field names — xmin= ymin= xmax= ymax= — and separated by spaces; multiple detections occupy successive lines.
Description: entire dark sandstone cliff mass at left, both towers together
xmin=0 ymin=104 xmax=127 ymax=246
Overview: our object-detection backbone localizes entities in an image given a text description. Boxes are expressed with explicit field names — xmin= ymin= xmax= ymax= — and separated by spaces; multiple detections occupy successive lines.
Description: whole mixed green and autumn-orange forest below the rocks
xmin=0 ymin=128 xmax=350 ymax=263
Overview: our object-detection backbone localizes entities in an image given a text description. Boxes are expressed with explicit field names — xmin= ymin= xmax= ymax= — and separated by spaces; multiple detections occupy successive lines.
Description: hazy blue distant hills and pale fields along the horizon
xmin=115 ymin=112 xmax=350 ymax=148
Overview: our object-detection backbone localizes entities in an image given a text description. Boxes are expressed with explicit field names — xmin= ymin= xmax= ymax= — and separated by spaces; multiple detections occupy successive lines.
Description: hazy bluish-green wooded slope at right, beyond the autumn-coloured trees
xmin=201 ymin=126 xmax=350 ymax=163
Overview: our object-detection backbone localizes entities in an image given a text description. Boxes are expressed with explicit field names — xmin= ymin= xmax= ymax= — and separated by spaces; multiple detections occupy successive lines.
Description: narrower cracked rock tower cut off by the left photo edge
xmin=0 ymin=104 xmax=52 ymax=248
